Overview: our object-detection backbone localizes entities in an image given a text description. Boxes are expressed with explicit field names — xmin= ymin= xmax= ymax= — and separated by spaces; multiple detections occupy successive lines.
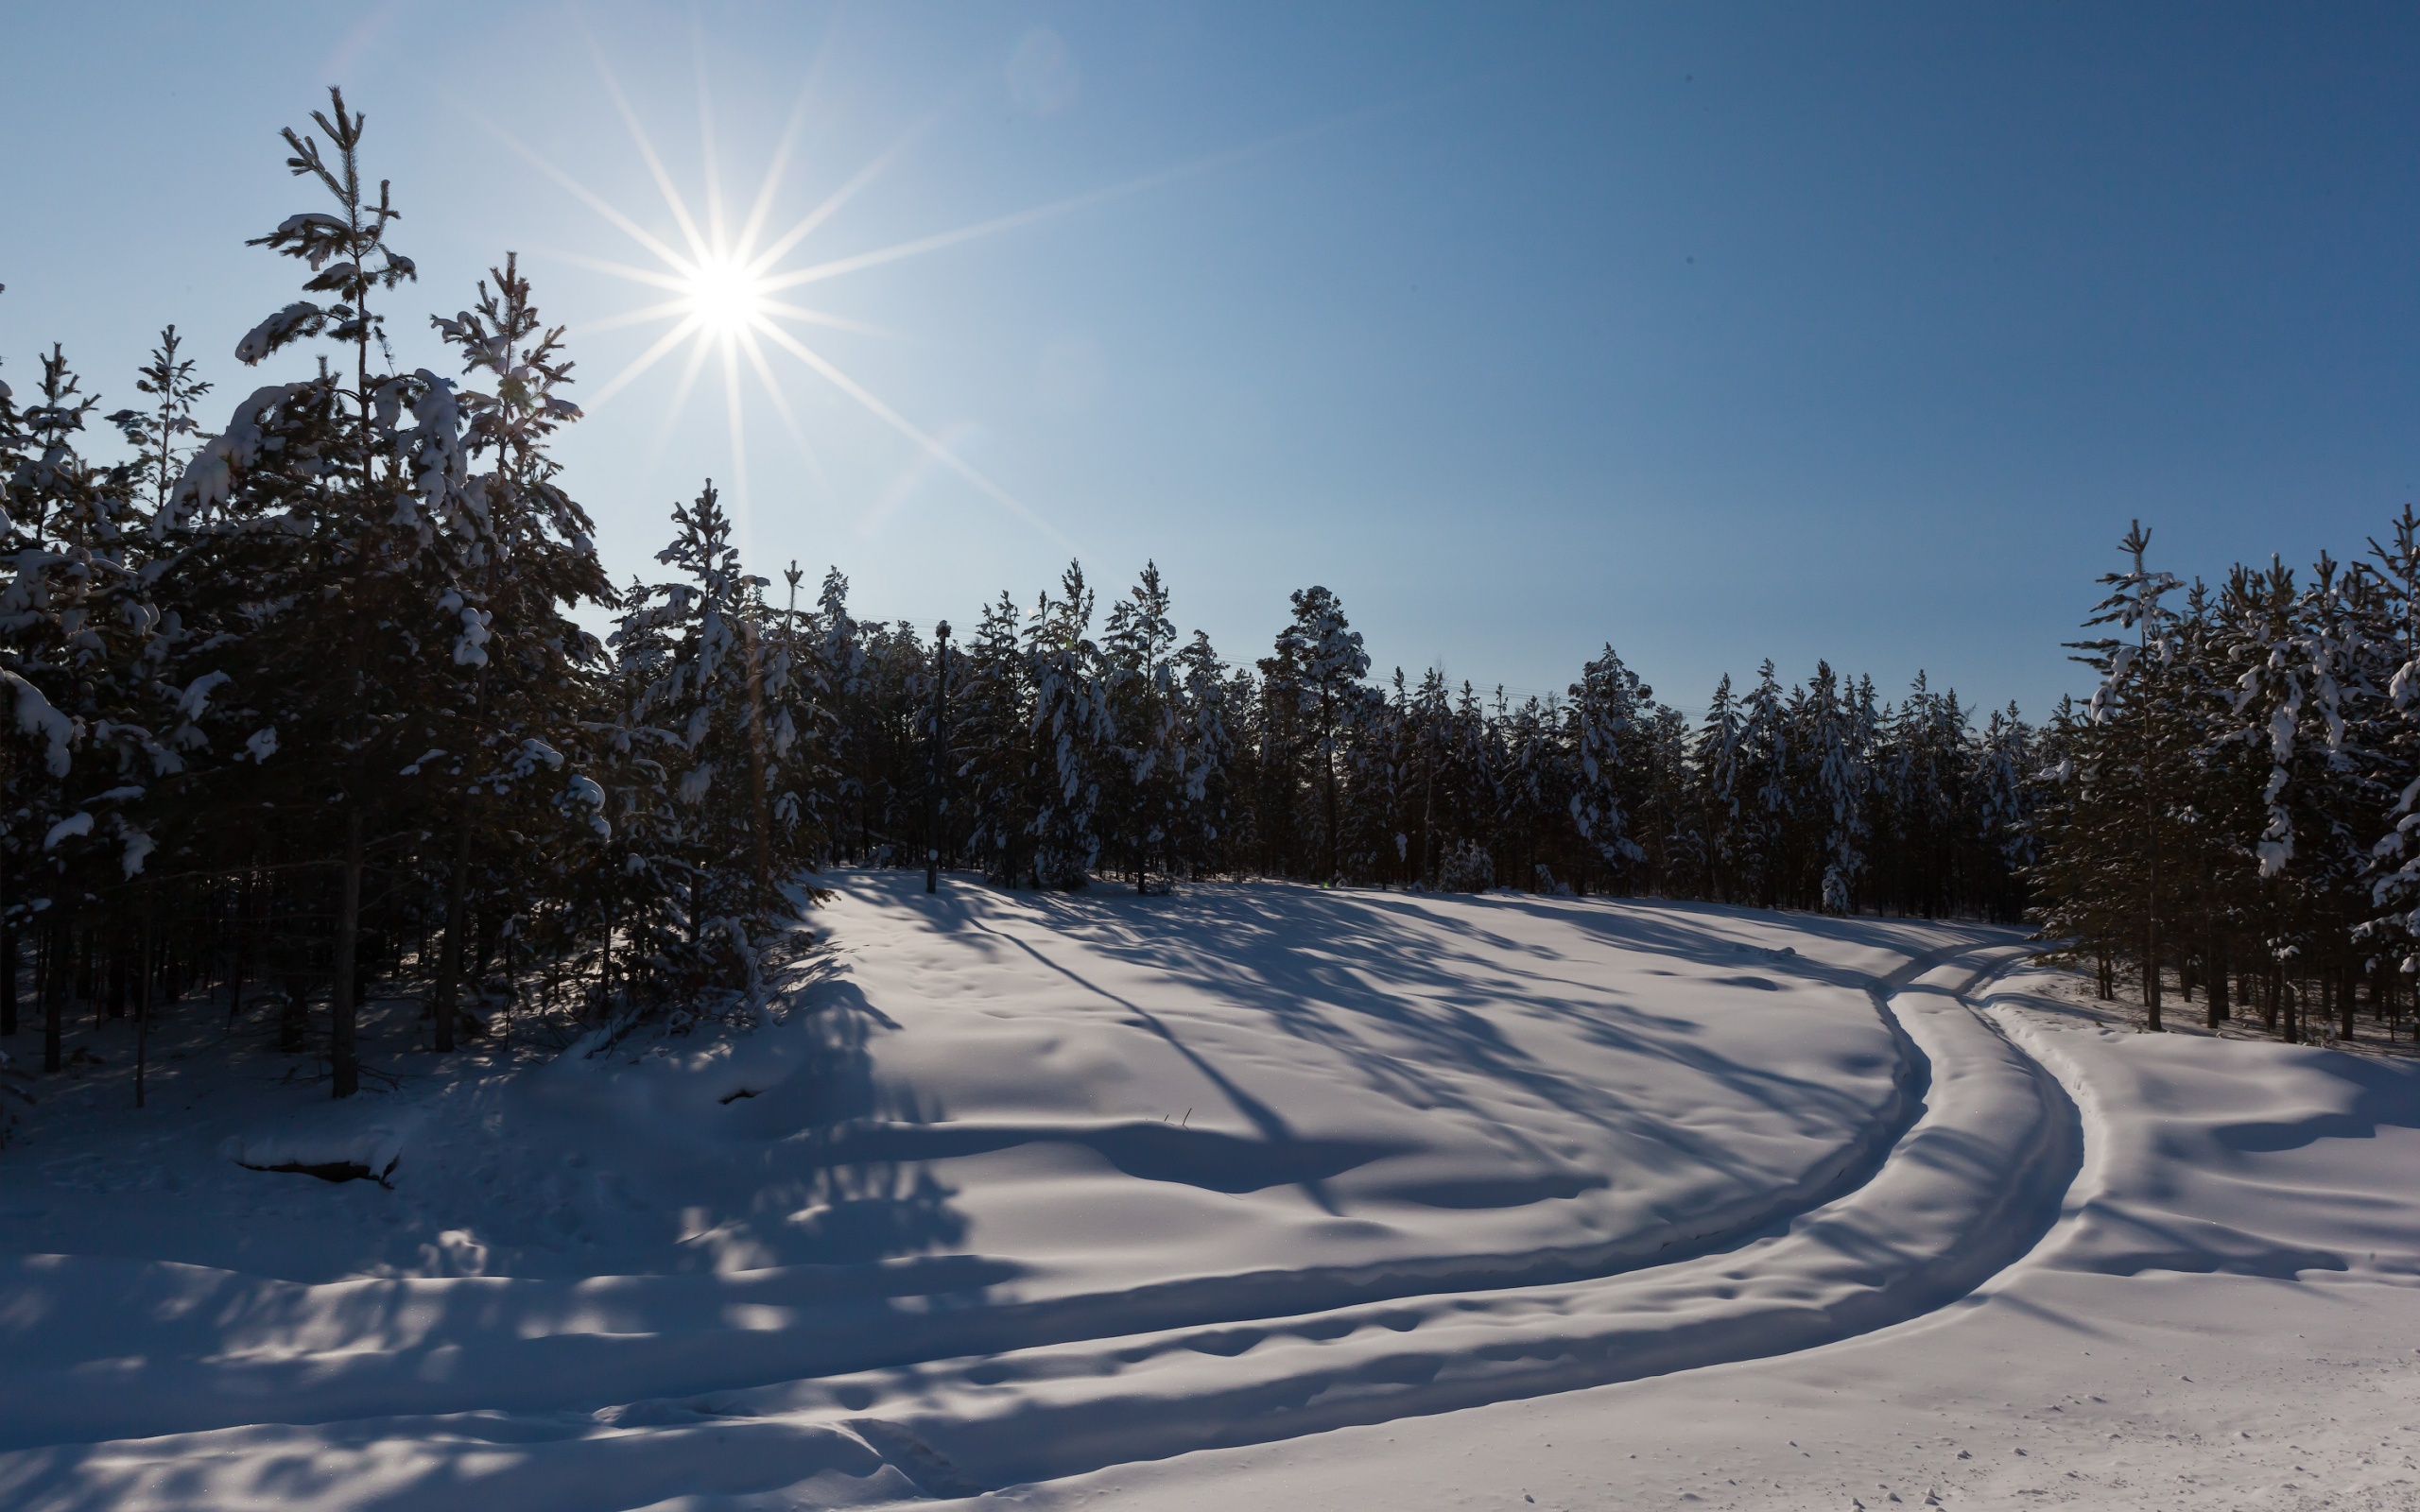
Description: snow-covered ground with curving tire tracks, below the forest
xmin=0 ymin=873 xmax=2420 ymax=1512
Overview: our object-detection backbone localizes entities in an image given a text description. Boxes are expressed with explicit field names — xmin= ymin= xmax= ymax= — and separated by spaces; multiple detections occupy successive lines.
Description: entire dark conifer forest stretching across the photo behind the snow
xmin=0 ymin=94 xmax=2420 ymax=1122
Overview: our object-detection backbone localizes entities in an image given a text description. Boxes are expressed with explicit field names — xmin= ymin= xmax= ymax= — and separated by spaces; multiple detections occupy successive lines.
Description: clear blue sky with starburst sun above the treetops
xmin=0 ymin=0 xmax=2420 ymax=713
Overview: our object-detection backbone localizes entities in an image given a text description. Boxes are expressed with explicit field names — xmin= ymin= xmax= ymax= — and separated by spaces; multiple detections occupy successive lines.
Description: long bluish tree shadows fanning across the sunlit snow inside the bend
xmin=859 ymin=873 xmax=2014 ymax=1194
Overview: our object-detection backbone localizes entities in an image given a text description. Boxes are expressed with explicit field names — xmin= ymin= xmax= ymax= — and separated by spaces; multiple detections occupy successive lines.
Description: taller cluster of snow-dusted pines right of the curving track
xmin=2032 ymin=506 xmax=2420 ymax=1040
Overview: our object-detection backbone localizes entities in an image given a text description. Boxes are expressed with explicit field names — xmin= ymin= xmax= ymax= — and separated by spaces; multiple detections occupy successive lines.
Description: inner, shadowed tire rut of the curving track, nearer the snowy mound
xmin=0 ymin=919 xmax=1945 ymax=1447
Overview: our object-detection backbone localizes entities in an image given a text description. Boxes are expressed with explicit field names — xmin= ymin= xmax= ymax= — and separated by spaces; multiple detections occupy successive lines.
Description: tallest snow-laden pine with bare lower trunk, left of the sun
xmin=172 ymin=90 xmax=442 ymax=1098
